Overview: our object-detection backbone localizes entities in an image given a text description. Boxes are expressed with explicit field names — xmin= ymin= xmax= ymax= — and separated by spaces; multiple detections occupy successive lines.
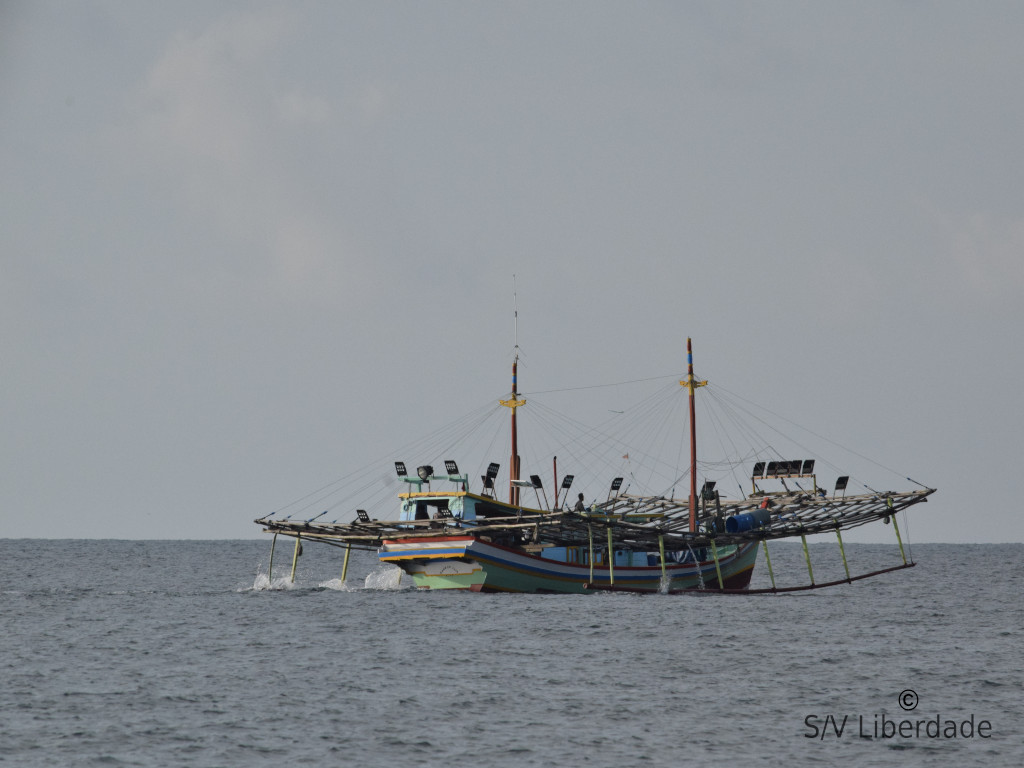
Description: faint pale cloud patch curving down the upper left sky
xmin=127 ymin=6 xmax=348 ymax=305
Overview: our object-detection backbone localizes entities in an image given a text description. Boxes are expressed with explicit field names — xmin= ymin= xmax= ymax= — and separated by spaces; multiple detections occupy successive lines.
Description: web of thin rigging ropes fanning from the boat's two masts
xmin=268 ymin=368 xmax=924 ymax=518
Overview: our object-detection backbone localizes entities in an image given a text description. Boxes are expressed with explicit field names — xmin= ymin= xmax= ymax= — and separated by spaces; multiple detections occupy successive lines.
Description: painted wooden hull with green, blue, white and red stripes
xmin=379 ymin=536 xmax=757 ymax=593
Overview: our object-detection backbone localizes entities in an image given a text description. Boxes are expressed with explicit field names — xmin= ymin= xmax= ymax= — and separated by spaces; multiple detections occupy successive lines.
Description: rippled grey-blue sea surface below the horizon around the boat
xmin=0 ymin=540 xmax=1024 ymax=768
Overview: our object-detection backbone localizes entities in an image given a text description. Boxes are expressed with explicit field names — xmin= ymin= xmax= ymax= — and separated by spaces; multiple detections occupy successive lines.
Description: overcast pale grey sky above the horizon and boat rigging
xmin=0 ymin=0 xmax=1024 ymax=542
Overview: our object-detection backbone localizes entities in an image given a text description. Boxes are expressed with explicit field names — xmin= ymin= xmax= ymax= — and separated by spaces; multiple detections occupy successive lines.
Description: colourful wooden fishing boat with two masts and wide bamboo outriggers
xmin=256 ymin=340 xmax=935 ymax=594
